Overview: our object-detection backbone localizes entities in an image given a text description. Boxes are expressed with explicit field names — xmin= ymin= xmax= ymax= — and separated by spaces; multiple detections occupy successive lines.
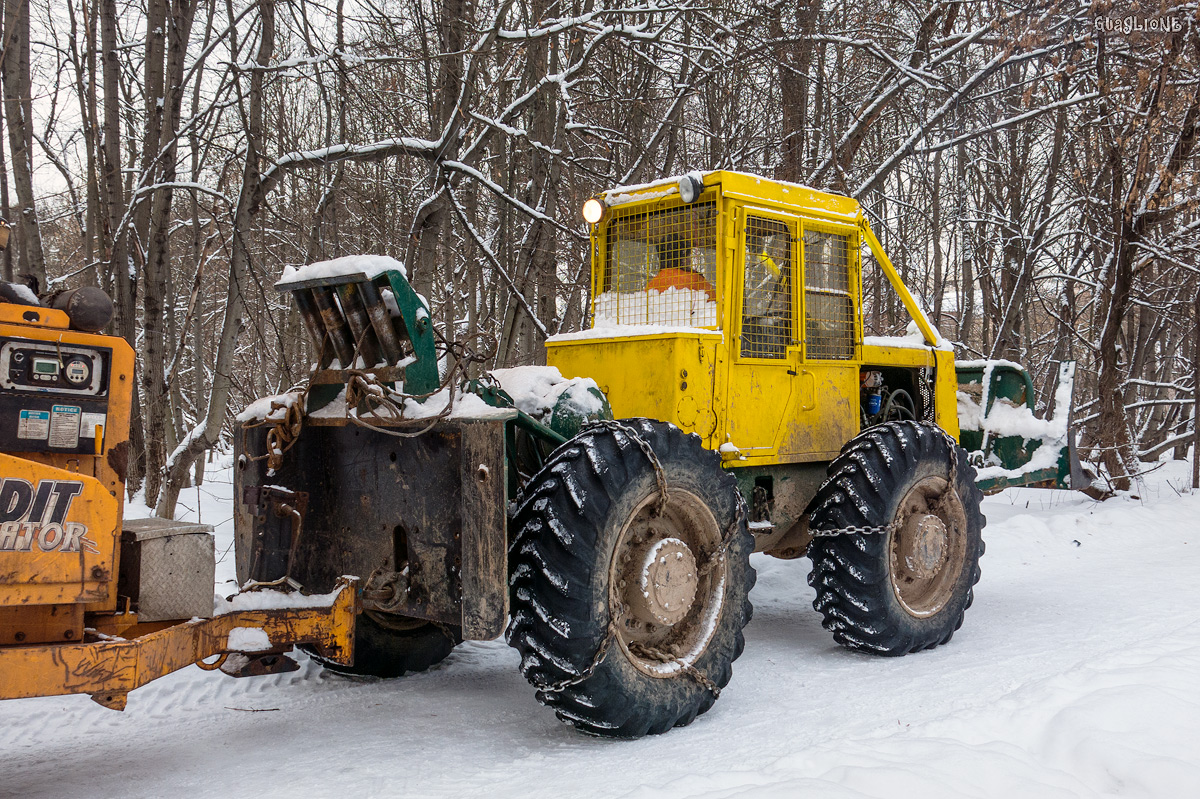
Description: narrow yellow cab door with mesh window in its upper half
xmin=726 ymin=209 xmax=800 ymax=465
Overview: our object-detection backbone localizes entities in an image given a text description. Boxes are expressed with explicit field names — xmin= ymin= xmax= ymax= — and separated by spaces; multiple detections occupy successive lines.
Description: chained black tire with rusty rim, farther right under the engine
xmin=809 ymin=421 xmax=985 ymax=655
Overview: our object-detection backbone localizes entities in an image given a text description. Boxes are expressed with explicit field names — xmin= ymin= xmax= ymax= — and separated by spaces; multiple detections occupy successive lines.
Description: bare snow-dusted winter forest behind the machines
xmin=0 ymin=0 xmax=1200 ymax=515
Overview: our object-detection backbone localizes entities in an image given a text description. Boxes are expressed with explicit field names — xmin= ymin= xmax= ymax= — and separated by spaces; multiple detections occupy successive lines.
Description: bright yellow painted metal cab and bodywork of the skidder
xmin=547 ymin=172 xmax=959 ymax=467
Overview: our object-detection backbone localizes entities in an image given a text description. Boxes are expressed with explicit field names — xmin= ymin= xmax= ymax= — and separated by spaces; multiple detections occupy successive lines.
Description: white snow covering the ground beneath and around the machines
xmin=0 ymin=453 xmax=1200 ymax=799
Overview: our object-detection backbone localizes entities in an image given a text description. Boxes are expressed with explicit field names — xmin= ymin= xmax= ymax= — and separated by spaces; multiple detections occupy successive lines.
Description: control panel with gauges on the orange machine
xmin=0 ymin=338 xmax=109 ymax=397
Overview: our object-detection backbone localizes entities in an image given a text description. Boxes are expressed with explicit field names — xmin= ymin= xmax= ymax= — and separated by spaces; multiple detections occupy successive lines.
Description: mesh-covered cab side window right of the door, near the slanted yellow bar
xmin=804 ymin=230 xmax=854 ymax=360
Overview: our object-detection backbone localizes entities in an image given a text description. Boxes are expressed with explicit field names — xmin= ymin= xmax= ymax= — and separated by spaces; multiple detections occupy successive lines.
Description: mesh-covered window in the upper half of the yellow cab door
xmin=742 ymin=216 xmax=796 ymax=358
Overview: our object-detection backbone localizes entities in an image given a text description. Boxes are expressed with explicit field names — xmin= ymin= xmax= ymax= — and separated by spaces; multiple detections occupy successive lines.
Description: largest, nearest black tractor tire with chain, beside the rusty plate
xmin=505 ymin=419 xmax=755 ymax=738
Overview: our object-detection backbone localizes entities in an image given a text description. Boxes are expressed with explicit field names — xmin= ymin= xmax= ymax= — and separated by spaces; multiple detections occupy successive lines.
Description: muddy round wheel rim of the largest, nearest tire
xmin=608 ymin=489 xmax=728 ymax=678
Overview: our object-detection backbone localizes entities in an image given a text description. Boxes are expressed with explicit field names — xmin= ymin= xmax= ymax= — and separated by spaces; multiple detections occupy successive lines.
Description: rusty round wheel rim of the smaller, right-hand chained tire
xmin=889 ymin=476 xmax=967 ymax=618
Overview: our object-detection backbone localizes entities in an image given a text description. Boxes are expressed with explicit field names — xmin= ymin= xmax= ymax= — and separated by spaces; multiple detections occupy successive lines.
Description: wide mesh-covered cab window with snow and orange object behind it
xmin=594 ymin=200 xmax=718 ymax=328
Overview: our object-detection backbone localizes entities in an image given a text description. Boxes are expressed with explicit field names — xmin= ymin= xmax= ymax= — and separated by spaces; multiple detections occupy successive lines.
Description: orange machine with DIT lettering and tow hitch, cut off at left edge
xmin=0 ymin=223 xmax=358 ymax=710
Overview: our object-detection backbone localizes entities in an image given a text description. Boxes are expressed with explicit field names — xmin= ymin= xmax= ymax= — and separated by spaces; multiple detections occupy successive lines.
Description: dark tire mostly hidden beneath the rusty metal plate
xmin=302 ymin=613 xmax=462 ymax=677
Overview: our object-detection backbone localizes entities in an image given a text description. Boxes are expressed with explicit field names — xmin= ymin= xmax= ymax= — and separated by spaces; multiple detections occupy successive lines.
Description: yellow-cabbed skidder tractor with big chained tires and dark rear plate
xmin=234 ymin=172 xmax=984 ymax=738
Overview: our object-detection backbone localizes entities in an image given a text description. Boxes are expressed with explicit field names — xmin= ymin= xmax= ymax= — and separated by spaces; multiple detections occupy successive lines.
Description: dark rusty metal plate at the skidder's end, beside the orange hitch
xmin=234 ymin=420 xmax=508 ymax=639
